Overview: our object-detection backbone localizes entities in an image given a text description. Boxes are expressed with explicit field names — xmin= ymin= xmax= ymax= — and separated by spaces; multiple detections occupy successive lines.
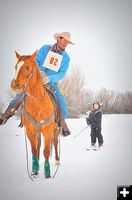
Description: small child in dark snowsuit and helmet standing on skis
xmin=86 ymin=101 xmax=103 ymax=149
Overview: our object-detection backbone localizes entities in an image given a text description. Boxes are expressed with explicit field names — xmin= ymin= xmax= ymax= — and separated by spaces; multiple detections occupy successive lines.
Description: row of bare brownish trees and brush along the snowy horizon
xmin=4 ymin=66 xmax=132 ymax=118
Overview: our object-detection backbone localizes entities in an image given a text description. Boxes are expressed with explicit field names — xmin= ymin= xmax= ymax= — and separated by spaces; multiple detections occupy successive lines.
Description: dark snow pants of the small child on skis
xmin=91 ymin=128 xmax=103 ymax=145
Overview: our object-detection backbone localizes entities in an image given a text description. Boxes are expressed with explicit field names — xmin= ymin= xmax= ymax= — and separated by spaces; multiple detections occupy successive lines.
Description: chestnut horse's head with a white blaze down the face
xmin=11 ymin=52 xmax=37 ymax=92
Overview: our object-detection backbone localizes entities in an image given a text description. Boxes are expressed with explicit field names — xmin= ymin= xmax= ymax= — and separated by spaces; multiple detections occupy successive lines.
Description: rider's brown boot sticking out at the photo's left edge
xmin=0 ymin=100 xmax=21 ymax=125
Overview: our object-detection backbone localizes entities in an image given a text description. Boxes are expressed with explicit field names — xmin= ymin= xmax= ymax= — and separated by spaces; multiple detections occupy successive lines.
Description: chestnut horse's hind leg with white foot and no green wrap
xmin=53 ymin=128 xmax=59 ymax=165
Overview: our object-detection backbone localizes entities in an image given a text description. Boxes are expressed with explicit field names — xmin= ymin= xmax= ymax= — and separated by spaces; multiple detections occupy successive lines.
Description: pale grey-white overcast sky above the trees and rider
xmin=0 ymin=0 xmax=132 ymax=101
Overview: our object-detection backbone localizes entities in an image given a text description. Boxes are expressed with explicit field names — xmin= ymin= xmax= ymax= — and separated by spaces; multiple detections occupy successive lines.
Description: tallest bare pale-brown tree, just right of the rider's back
xmin=60 ymin=67 xmax=85 ymax=117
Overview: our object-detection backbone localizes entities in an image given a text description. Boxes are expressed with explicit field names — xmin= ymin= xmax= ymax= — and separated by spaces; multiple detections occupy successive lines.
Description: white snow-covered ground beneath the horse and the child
xmin=0 ymin=115 xmax=132 ymax=200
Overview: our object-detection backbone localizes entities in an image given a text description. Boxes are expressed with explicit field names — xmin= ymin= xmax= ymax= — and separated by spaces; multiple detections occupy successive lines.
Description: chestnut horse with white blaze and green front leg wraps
xmin=11 ymin=52 xmax=59 ymax=178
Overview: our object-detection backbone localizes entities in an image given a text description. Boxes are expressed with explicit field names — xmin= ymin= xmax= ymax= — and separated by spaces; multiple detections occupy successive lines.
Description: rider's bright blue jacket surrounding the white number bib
xmin=35 ymin=45 xmax=70 ymax=85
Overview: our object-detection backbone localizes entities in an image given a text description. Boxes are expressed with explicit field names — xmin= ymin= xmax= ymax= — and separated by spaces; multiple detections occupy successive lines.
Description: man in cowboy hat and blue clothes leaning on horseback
xmin=0 ymin=32 xmax=74 ymax=136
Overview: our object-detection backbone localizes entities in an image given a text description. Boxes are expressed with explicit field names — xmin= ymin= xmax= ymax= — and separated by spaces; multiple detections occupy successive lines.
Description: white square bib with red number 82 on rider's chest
xmin=44 ymin=51 xmax=62 ymax=72
